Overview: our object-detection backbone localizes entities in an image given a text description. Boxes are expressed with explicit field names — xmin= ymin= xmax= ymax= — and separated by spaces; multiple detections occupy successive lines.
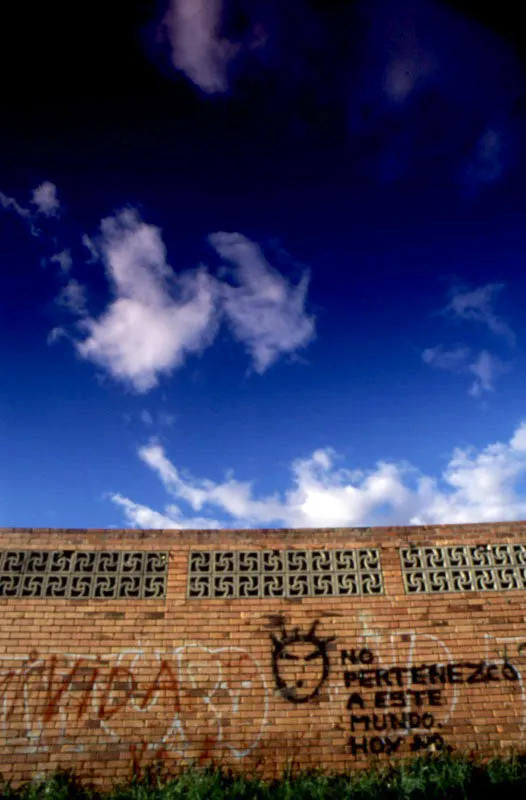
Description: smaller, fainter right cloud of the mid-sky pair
xmin=209 ymin=232 xmax=315 ymax=373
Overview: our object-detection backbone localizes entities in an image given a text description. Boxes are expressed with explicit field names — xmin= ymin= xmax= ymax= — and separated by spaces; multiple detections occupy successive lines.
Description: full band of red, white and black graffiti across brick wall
xmin=0 ymin=614 xmax=526 ymax=771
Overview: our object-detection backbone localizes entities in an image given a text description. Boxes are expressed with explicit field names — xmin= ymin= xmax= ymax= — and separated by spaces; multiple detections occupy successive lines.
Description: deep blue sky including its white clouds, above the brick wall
xmin=0 ymin=0 xmax=526 ymax=528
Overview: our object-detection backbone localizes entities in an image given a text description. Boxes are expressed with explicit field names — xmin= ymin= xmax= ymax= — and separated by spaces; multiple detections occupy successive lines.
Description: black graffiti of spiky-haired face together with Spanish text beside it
xmin=269 ymin=615 xmax=526 ymax=756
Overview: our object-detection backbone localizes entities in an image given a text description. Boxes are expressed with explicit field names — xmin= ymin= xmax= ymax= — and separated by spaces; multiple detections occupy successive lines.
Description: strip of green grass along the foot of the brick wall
xmin=0 ymin=756 xmax=526 ymax=800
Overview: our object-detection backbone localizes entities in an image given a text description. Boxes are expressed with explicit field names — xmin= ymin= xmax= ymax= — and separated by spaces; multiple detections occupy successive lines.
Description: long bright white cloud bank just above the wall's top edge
xmin=112 ymin=423 xmax=526 ymax=528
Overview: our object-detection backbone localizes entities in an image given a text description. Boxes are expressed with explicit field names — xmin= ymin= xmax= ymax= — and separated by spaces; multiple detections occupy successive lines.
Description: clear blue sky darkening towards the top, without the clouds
xmin=0 ymin=2 xmax=526 ymax=527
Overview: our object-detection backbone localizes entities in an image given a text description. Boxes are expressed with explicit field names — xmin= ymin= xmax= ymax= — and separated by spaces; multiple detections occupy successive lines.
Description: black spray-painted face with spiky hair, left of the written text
xmin=270 ymin=620 xmax=336 ymax=703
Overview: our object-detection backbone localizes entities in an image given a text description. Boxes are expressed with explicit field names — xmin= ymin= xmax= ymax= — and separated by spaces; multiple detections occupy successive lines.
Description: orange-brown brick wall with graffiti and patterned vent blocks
xmin=0 ymin=523 xmax=526 ymax=782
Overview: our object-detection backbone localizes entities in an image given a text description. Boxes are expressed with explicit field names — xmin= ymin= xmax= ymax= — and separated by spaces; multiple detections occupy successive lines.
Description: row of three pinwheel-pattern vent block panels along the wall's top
xmin=0 ymin=544 xmax=526 ymax=600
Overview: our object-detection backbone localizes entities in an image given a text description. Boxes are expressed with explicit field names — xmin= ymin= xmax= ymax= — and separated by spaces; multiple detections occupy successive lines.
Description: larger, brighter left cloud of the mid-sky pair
xmin=72 ymin=210 xmax=218 ymax=392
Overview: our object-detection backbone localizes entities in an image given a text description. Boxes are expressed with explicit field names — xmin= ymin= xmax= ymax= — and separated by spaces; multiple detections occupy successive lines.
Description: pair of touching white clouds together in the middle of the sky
xmin=55 ymin=209 xmax=314 ymax=392
